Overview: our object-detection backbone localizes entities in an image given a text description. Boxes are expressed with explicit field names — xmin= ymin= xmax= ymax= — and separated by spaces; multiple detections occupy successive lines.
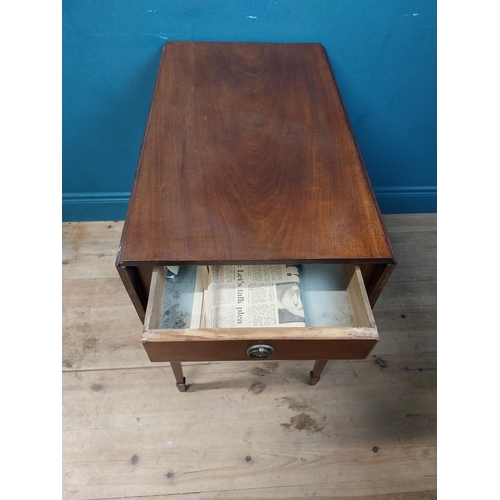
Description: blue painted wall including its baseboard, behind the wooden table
xmin=62 ymin=0 xmax=436 ymax=221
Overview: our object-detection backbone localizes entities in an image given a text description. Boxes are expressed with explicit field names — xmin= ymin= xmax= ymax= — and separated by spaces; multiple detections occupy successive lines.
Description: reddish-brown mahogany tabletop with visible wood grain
xmin=118 ymin=42 xmax=394 ymax=265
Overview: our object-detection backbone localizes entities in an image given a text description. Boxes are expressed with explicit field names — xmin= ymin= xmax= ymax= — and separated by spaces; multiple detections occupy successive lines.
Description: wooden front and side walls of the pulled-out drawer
xmin=142 ymin=265 xmax=379 ymax=362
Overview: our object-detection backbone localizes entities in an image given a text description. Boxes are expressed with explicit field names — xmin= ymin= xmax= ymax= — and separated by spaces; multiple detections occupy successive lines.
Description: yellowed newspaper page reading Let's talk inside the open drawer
xmin=205 ymin=264 xmax=305 ymax=328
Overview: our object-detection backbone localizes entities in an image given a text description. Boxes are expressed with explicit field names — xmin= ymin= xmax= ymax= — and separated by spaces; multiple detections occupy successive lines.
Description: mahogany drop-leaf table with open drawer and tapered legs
xmin=116 ymin=42 xmax=396 ymax=391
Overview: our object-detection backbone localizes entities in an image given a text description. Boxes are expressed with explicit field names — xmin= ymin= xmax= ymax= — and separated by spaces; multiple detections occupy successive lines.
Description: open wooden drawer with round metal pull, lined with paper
xmin=142 ymin=264 xmax=379 ymax=362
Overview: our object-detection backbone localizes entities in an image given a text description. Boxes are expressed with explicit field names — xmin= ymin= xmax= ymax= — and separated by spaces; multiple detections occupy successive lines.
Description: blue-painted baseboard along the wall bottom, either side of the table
xmin=62 ymin=186 xmax=437 ymax=222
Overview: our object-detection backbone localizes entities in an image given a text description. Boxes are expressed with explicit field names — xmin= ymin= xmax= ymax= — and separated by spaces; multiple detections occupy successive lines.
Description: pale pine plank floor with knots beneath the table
xmin=62 ymin=214 xmax=437 ymax=500
